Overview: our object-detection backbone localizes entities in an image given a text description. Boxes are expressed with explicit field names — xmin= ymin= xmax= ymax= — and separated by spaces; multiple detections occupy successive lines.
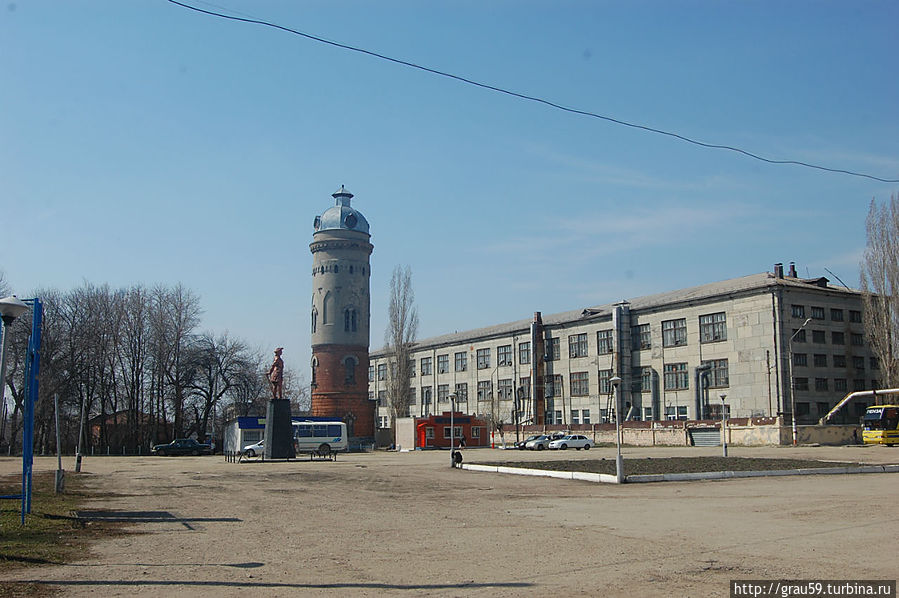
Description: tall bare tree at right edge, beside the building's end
xmin=861 ymin=195 xmax=899 ymax=388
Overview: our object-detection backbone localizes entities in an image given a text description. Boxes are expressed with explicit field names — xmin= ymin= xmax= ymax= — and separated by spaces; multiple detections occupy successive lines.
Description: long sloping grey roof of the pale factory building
xmin=372 ymin=272 xmax=859 ymax=355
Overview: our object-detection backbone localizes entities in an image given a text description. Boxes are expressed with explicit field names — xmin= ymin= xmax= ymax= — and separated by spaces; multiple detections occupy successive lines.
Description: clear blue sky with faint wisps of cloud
xmin=0 ymin=0 xmax=899 ymax=381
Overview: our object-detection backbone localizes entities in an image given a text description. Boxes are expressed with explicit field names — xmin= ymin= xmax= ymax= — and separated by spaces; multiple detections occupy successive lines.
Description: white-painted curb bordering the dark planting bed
xmin=462 ymin=463 xmax=899 ymax=484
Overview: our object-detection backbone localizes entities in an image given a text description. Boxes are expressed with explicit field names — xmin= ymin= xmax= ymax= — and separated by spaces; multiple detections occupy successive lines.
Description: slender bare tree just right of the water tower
xmin=384 ymin=266 xmax=418 ymax=442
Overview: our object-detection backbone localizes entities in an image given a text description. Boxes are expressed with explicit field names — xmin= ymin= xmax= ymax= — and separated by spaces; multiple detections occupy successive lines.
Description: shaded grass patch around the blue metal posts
xmin=0 ymin=472 xmax=133 ymax=598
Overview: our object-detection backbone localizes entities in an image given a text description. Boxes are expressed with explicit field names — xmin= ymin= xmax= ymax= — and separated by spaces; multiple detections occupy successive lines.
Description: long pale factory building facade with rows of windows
xmin=368 ymin=264 xmax=879 ymax=427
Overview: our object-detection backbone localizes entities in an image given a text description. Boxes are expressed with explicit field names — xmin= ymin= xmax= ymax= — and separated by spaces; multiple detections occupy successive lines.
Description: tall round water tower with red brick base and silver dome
xmin=309 ymin=185 xmax=375 ymax=442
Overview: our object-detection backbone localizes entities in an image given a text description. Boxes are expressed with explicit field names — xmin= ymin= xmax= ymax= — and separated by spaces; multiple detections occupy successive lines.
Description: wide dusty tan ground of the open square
xmin=0 ymin=446 xmax=899 ymax=598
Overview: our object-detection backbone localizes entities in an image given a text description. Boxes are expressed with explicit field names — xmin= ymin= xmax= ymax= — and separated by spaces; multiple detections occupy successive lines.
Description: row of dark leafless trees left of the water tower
xmin=0 ymin=276 xmax=309 ymax=454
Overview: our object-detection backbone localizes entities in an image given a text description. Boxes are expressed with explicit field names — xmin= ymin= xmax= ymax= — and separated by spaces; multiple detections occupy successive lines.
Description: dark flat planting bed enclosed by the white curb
xmin=484 ymin=457 xmax=858 ymax=475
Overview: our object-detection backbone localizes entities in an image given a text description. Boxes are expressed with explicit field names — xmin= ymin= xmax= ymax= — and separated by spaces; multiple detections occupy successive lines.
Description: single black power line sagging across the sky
xmin=167 ymin=0 xmax=899 ymax=183
